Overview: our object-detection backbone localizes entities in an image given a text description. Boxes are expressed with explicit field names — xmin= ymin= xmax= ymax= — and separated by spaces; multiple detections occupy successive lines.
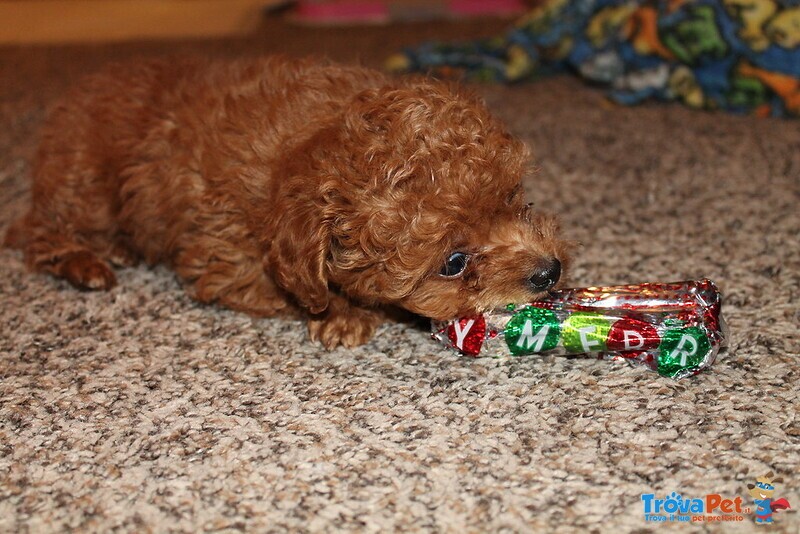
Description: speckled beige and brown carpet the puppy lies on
xmin=0 ymin=18 xmax=800 ymax=532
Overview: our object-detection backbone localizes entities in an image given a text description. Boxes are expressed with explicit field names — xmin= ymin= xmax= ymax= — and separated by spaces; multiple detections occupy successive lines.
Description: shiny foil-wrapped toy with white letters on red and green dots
xmin=433 ymin=279 xmax=725 ymax=378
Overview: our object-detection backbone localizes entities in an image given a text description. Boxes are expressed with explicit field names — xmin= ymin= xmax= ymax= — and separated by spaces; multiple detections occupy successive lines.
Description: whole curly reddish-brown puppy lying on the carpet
xmin=6 ymin=58 xmax=566 ymax=348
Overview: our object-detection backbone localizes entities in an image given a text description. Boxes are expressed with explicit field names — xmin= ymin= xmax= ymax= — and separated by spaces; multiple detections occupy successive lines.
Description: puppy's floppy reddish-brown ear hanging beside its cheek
xmin=265 ymin=176 xmax=331 ymax=314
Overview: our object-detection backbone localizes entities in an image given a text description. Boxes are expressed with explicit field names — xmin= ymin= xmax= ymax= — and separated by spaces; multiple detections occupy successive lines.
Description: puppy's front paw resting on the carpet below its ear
xmin=308 ymin=303 xmax=381 ymax=350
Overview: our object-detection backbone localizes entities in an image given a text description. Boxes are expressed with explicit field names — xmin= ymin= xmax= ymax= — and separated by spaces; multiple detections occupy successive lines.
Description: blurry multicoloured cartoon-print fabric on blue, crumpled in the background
xmin=387 ymin=0 xmax=800 ymax=117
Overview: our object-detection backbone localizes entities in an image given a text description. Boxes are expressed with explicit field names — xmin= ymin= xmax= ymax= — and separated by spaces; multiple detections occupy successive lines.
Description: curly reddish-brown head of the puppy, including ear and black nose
xmin=277 ymin=80 xmax=568 ymax=320
